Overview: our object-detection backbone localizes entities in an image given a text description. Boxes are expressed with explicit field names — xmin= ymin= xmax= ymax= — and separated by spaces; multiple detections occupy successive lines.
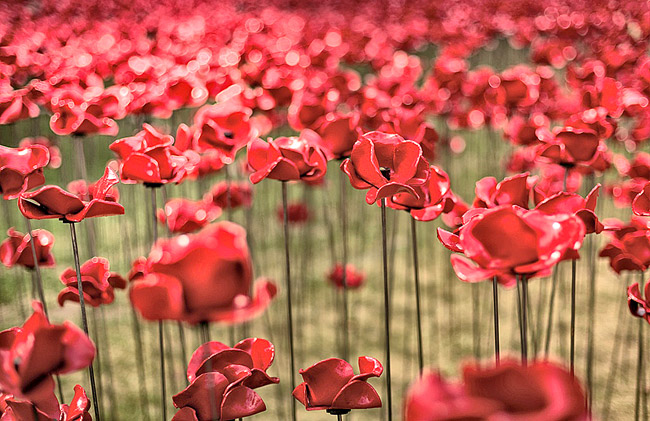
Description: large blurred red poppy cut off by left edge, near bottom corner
xmin=0 ymin=302 xmax=95 ymax=419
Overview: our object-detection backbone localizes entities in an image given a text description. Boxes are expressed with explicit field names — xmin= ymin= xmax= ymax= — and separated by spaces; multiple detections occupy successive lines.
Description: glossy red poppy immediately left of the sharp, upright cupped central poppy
xmin=248 ymin=134 xmax=327 ymax=184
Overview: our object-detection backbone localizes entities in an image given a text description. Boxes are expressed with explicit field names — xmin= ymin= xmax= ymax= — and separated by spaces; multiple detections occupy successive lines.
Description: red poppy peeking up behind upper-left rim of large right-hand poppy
xmin=472 ymin=173 xmax=537 ymax=209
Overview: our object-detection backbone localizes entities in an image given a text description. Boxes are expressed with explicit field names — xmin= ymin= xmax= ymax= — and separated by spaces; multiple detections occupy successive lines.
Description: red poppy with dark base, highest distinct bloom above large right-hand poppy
xmin=537 ymin=127 xmax=606 ymax=167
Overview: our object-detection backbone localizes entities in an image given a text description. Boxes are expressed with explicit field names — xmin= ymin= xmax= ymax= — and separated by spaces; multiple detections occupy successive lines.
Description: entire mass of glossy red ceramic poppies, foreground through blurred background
xmin=0 ymin=0 xmax=650 ymax=421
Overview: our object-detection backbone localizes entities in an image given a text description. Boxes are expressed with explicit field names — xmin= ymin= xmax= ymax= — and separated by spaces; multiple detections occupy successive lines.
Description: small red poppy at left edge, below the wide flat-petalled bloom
xmin=0 ymin=228 xmax=55 ymax=269
